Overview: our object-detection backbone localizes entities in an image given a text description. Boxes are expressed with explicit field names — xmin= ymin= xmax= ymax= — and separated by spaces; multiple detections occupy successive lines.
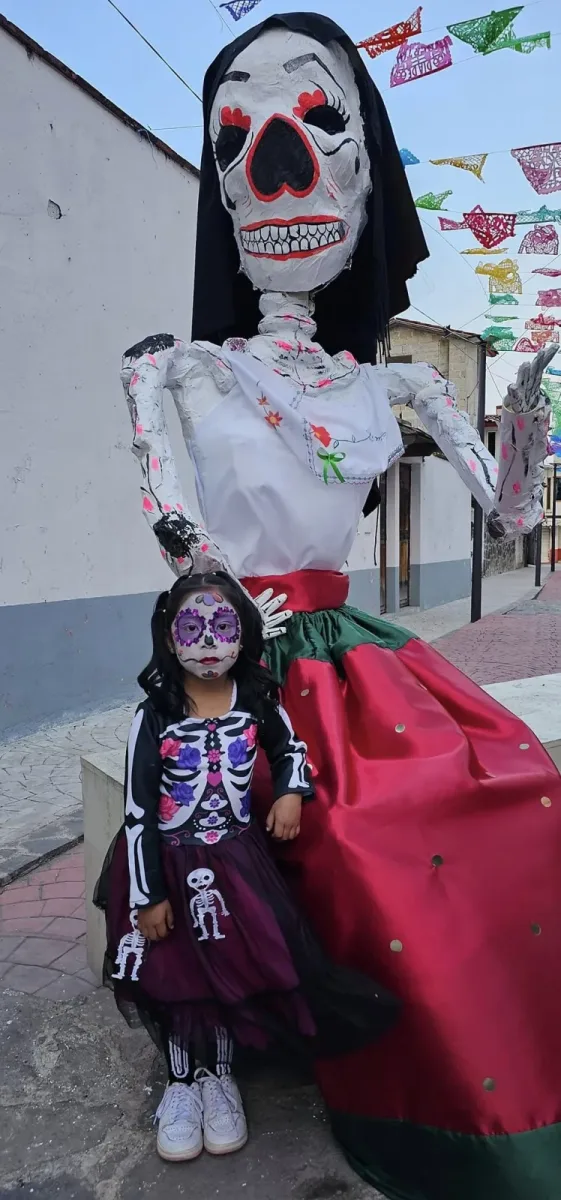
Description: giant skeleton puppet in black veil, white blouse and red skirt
xmin=122 ymin=13 xmax=561 ymax=1200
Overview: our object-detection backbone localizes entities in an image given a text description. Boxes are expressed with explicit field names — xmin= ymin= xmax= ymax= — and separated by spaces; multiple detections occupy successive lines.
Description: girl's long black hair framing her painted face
xmin=138 ymin=571 xmax=277 ymax=721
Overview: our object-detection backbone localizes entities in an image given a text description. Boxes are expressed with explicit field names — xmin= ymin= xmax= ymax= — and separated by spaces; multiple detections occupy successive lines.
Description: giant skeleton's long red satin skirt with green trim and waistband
xmin=245 ymin=571 xmax=561 ymax=1200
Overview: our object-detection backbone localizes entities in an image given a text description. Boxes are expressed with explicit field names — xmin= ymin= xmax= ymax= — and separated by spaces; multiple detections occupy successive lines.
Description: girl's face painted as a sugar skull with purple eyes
xmin=171 ymin=590 xmax=241 ymax=679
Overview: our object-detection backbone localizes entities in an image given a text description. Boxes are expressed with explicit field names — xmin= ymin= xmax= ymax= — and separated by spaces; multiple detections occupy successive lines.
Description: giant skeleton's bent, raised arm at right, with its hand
xmin=374 ymin=348 xmax=555 ymax=538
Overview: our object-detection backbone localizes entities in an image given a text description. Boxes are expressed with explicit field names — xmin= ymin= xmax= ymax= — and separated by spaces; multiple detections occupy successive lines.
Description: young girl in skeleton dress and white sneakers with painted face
xmin=96 ymin=572 xmax=397 ymax=1160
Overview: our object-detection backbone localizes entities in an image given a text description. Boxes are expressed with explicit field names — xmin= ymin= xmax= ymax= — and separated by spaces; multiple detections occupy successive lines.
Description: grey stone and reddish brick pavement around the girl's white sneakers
xmin=0 ymin=848 xmax=382 ymax=1200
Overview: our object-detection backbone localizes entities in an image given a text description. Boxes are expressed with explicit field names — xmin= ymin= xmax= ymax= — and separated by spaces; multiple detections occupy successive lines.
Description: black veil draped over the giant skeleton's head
xmin=192 ymin=12 xmax=429 ymax=362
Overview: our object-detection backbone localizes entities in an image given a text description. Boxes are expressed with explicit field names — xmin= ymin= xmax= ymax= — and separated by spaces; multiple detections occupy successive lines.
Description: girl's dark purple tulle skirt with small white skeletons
xmin=95 ymin=824 xmax=398 ymax=1056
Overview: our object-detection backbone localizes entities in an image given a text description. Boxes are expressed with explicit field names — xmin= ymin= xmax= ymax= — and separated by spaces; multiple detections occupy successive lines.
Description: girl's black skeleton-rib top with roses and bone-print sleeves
xmin=125 ymin=688 xmax=312 ymax=907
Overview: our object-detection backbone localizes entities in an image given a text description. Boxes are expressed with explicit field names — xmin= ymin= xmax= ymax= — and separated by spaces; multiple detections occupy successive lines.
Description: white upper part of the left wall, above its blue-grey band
xmin=0 ymin=30 xmax=198 ymax=605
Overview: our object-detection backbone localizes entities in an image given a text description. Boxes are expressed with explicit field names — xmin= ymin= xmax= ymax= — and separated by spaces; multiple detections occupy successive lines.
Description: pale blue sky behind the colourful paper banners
xmin=1 ymin=0 xmax=561 ymax=409
